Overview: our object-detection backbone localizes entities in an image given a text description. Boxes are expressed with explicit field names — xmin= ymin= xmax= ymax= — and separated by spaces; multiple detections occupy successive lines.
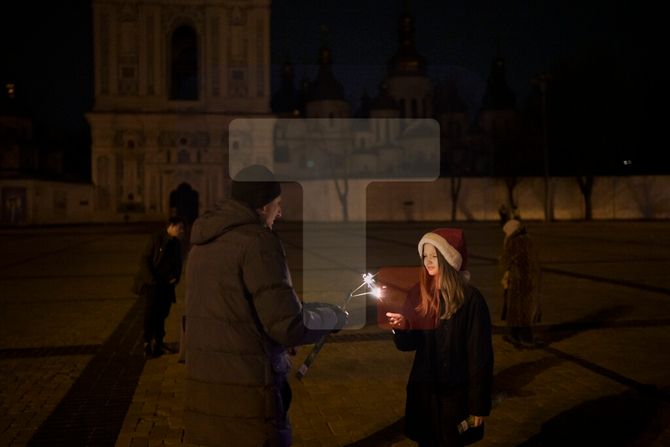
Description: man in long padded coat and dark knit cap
xmin=184 ymin=166 xmax=347 ymax=447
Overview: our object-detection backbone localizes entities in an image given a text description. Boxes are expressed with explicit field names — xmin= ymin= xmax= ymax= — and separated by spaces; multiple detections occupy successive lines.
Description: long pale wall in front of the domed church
xmin=272 ymin=176 xmax=670 ymax=222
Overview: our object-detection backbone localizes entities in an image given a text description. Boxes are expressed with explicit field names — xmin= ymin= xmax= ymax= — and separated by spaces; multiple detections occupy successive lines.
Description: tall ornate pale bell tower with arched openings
xmin=87 ymin=0 xmax=270 ymax=221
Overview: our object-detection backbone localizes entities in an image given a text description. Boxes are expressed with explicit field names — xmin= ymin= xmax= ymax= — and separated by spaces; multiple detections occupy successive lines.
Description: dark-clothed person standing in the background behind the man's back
xmin=133 ymin=216 xmax=184 ymax=357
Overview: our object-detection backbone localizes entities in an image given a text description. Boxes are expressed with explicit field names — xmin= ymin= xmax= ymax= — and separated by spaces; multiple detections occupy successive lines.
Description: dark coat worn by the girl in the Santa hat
xmin=394 ymin=284 xmax=493 ymax=445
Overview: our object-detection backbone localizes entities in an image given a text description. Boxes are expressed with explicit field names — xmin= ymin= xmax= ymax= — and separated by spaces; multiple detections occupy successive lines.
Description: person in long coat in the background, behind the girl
xmin=500 ymin=219 xmax=541 ymax=348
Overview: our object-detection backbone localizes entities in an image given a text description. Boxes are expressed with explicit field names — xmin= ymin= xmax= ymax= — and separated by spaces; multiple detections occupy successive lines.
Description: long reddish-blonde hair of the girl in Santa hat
xmin=416 ymin=250 xmax=465 ymax=326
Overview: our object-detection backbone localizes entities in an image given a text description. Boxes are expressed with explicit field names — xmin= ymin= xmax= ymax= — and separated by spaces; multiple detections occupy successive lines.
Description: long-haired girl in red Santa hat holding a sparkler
xmin=386 ymin=228 xmax=493 ymax=447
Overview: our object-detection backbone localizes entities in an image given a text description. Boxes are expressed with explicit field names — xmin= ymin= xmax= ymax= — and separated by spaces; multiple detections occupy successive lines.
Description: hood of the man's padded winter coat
xmin=191 ymin=200 xmax=262 ymax=245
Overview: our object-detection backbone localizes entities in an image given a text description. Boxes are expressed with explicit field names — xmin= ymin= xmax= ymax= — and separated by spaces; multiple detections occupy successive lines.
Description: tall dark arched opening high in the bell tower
xmin=170 ymin=25 xmax=198 ymax=101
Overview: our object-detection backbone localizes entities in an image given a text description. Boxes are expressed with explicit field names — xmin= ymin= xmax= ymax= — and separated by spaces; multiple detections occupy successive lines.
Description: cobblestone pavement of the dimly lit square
xmin=0 ymin=222 xmax=670 ymax=447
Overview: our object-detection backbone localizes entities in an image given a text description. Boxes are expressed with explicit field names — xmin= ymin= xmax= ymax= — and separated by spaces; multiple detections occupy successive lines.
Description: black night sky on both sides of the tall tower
xmin=0 ymin=0 xmax=667 ymax=177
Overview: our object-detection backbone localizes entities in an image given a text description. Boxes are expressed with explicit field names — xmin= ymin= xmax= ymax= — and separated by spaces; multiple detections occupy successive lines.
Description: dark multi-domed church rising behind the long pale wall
xmin=271 ymin=3 xmax=520 ymax=182
